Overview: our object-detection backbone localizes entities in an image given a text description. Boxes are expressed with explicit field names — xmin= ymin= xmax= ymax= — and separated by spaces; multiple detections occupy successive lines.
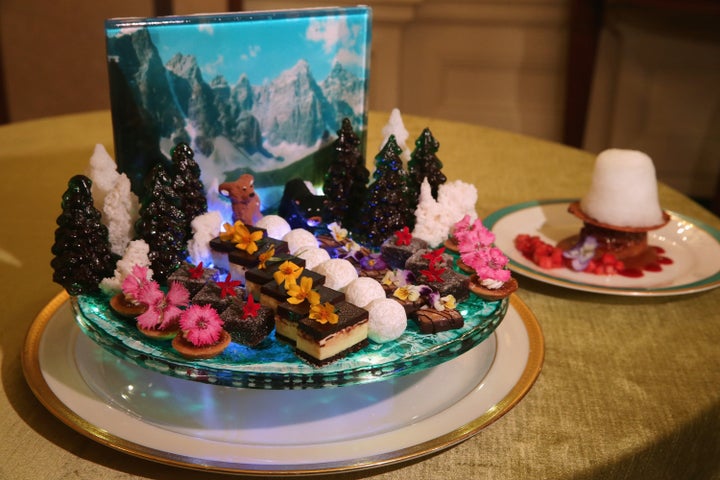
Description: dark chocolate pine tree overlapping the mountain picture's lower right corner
xmin=323 ymin=118 xmax=370 ymax=229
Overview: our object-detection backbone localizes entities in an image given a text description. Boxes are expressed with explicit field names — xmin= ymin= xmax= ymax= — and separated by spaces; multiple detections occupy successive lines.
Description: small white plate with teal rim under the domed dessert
xmin=484 ymin=199 xmax=720 ymax=296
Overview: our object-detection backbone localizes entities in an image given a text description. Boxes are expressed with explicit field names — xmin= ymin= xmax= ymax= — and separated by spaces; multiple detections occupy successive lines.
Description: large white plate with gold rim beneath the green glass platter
xmin=23 ymin=293 xmax=544 ymax=475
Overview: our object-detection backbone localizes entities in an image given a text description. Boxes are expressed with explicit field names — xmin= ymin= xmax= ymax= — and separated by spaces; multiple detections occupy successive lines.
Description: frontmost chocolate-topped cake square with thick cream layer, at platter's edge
xmin=295 ymin=302 xmax=368 ymax=366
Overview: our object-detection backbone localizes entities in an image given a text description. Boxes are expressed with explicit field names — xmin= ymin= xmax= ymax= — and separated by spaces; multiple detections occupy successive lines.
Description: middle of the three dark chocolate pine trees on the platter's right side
xmin=357 ymin=135 xmax=414 ymax=247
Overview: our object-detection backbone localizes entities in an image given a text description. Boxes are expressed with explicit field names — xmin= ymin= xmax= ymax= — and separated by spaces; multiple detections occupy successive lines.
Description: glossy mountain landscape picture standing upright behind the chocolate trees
xmin=106 ymin=7 xmax=370 ymax=209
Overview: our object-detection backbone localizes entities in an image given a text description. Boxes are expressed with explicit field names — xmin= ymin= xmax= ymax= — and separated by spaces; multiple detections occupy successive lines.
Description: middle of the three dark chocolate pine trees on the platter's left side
xmin=135 ymin=163 xmax=187 ymax=282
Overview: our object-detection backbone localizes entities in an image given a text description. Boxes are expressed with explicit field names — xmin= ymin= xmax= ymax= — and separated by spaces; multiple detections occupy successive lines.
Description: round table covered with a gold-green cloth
xmin=0 ymin=111 xmax=720 ymax=480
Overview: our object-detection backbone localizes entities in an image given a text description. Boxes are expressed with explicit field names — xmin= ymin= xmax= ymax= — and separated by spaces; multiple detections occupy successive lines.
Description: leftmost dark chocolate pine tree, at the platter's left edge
xmin=50 ymin=175 xmax=117 ymax=295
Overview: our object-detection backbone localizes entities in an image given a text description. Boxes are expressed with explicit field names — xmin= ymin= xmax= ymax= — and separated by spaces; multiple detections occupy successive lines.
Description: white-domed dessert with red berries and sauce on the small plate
xmin=514 ymin=149 xmax=672 ymax=277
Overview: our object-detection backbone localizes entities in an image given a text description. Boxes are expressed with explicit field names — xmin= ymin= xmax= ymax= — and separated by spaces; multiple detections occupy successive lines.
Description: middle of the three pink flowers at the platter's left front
xmin=137 ymin=281 xmax=190 ymax=330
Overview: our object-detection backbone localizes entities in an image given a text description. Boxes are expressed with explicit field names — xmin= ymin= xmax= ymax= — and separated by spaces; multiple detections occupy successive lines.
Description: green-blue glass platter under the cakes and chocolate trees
xmin=71 ymin=294 xmax=509 ymax=390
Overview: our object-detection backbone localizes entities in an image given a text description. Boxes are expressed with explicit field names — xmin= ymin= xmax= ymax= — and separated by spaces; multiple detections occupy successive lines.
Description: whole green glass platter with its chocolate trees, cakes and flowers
xmin=52 ymin=114 xmax=517 ymax=388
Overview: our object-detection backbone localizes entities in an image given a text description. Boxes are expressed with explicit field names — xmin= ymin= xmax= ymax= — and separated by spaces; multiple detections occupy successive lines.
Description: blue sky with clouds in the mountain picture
xmin=108 ymin=10 xmax=370 ymax=85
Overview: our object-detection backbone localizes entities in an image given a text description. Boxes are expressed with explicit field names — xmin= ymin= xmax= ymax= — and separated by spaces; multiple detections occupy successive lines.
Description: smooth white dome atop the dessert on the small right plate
xmin=580 ymin=148 xmax=665 ymax=228
